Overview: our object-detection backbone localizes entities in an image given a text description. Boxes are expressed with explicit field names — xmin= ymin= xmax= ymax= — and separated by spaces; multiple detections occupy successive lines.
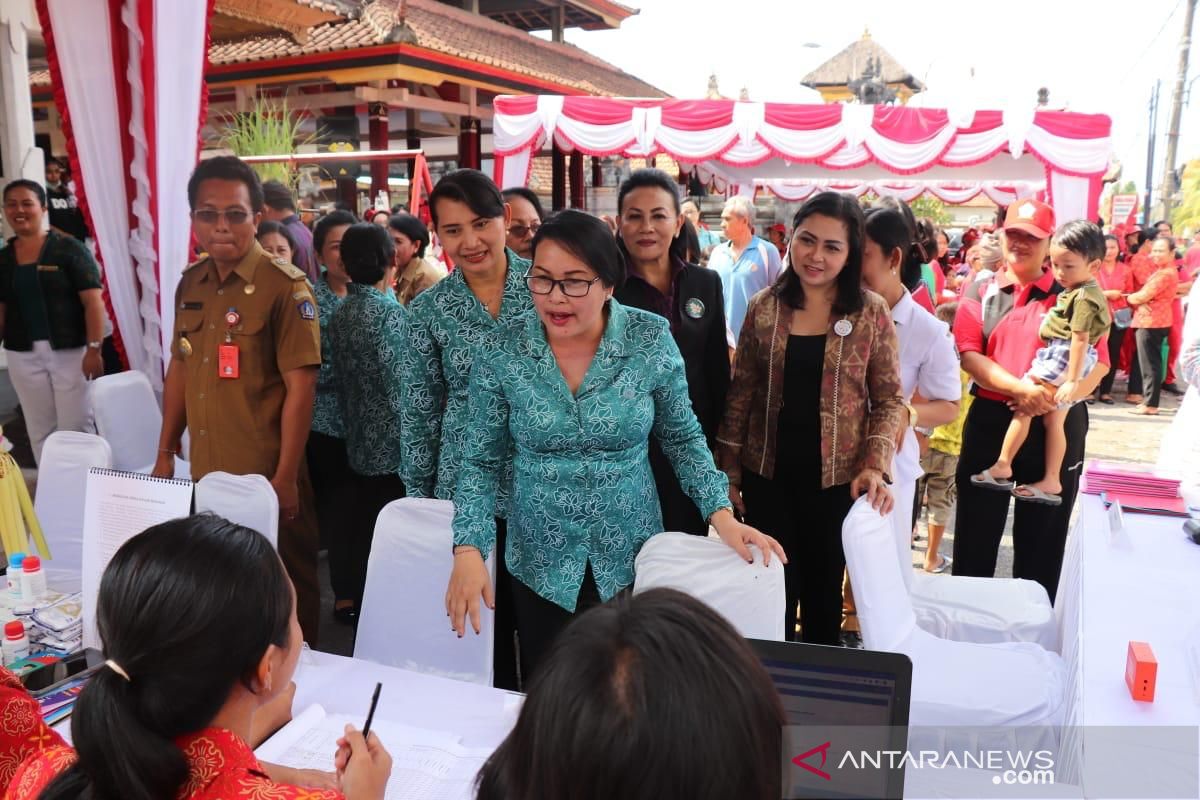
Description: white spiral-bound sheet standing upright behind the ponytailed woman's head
xmin=83 ymin=467 xmax=192 ymax=649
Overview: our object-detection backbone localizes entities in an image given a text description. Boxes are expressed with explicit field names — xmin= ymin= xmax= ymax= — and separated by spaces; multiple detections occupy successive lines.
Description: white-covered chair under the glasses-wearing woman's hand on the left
xmin=354 ymin=498 xmax=497 ymax=686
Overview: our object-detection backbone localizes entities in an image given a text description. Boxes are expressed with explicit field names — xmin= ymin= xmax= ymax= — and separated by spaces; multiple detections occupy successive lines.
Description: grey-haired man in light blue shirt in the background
xmin=708 ymin=196 xmax=781 ymax=347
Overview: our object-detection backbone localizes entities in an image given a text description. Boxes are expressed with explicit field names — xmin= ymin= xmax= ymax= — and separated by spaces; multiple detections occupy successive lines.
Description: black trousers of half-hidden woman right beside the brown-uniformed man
xmin=305 ymin=431 xmax=354 ymax=600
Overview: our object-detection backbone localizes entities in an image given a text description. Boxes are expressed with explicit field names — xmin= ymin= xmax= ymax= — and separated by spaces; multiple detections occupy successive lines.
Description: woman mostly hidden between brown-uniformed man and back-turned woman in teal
xmin=300 ymin=211 xmax=359 ymax=625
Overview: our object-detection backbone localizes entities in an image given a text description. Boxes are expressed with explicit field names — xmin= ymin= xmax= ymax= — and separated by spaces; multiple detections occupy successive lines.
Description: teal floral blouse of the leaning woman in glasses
xmin=454 ymin=300 xmax=730 ymax=612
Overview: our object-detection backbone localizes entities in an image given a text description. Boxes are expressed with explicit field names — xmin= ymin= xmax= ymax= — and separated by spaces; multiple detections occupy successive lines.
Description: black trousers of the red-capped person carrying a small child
xmin=953 ymin=397 xmax=1087 ymax=601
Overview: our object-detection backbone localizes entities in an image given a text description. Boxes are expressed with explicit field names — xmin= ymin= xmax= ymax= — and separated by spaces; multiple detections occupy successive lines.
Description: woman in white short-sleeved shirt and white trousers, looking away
xmin=863 ymin=207 xmax=962 ymax=572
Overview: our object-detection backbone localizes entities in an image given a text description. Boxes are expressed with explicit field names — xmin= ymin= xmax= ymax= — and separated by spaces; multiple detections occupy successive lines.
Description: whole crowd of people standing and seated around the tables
xmin=0 ymin=157 xmax=1200 ymax=798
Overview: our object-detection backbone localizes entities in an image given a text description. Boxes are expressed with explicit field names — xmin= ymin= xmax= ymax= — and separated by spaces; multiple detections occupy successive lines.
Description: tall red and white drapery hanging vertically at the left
xmin=36 ymin=0 xmax=212 ymax=386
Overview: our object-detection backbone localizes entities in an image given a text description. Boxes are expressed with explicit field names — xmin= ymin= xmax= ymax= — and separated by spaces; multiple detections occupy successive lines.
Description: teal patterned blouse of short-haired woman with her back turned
xmin=329 ymin=283 xmax=404 ymax=475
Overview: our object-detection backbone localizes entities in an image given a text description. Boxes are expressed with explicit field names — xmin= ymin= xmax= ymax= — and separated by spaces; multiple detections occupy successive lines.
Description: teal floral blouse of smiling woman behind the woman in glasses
xmin=401 ymin=251 xmax=533 ymax=506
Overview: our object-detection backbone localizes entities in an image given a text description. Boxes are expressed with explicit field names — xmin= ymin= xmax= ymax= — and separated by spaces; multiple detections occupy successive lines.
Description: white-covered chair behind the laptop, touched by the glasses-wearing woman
xmin=634 ymin=533 xmax=787 ymax=642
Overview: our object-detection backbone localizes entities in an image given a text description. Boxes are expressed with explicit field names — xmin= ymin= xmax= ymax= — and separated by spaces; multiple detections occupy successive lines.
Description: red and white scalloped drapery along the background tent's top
xmin=492 ymin=96 xmax=1111 ymax=219
